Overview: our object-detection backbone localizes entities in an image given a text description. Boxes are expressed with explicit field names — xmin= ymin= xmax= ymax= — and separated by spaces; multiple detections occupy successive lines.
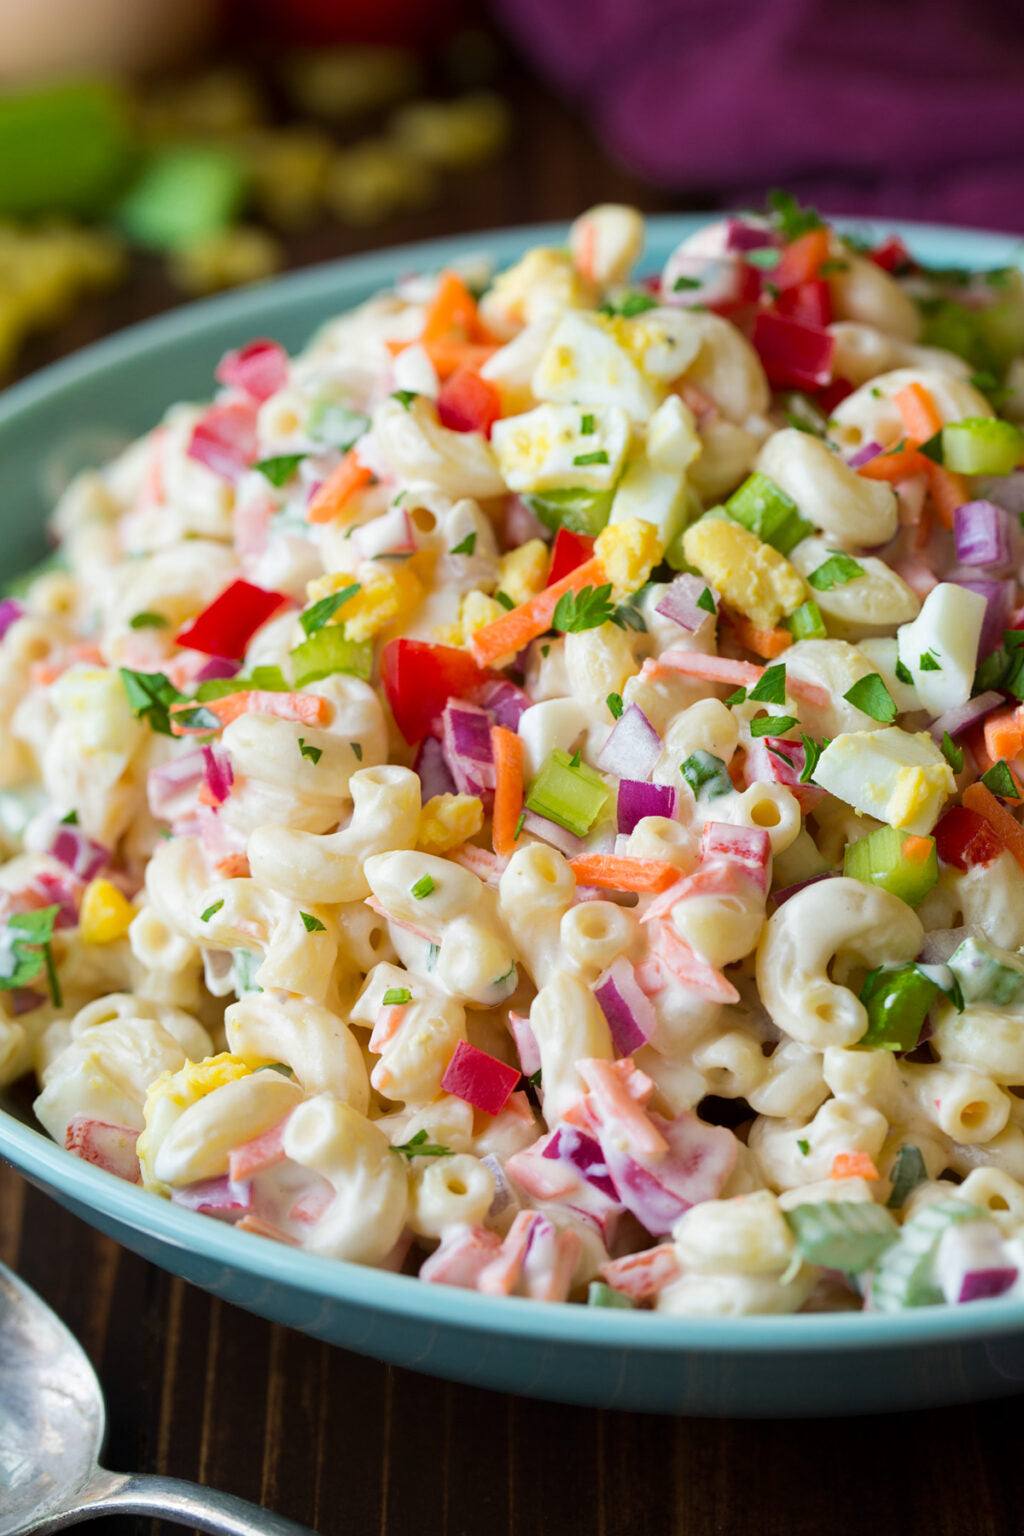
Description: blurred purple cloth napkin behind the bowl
xmin=496 ymin=0 xmax=1024 ymax=230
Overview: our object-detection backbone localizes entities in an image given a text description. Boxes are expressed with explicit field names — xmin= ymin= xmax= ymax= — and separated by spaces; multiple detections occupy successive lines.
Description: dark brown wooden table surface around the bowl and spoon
xmin=0 ymin=62 xmax=1024 ymax=1536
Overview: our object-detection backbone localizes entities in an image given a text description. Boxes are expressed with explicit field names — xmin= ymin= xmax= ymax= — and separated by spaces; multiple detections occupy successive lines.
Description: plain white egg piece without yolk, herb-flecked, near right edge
xmin=897 ymin=582 xmax=987 ymax=714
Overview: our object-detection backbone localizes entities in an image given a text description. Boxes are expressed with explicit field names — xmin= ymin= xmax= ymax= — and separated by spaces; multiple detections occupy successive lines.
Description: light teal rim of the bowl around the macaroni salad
xmin=0 ymin=212 xmax=1024 ymax=1353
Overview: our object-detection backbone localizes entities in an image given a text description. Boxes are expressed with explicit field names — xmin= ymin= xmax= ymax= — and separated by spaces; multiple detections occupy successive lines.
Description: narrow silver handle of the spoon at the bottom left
xmin=37 ymin=1467 xmax=313 ymax=1536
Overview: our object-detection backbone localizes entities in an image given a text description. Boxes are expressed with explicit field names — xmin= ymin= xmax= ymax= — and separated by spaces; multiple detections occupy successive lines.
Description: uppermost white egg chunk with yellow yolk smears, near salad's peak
xmin=533 ymin=310 xmax=662 ymax=421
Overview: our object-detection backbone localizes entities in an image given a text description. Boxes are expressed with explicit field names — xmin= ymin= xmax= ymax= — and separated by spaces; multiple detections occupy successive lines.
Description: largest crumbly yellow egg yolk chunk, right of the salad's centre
xmin=683 ymin=518 xmax=808 ymax=630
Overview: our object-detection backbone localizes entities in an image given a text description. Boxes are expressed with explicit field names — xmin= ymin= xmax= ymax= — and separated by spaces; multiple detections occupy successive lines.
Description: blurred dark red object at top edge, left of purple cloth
xmin=236 ymin=0 xmax=469 ymax=46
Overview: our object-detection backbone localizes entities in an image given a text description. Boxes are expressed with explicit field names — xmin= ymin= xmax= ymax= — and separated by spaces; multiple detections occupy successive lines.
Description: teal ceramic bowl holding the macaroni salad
xmin=0 ymin=218 xmax=1024 ymax=1418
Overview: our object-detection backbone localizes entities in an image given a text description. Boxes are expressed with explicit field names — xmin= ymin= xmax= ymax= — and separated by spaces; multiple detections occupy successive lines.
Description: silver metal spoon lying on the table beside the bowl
xmin=0 ymin=1264 xmax=312 ymax=1536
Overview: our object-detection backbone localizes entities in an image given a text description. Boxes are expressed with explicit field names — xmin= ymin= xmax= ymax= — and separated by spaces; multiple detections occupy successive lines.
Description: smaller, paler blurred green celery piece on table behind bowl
xmin=114 ymin=144 xmax=246 ymax=250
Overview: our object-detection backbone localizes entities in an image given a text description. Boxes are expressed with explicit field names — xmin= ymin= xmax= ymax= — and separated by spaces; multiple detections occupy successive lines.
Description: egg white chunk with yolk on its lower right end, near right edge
xmin=814 ymin=725 xmax=956 ymax=836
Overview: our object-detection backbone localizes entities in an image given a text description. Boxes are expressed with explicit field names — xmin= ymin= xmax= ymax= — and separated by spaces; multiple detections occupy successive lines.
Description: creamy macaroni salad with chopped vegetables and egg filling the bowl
xmin=0 ymin=194 xmax=1024 ymax=1315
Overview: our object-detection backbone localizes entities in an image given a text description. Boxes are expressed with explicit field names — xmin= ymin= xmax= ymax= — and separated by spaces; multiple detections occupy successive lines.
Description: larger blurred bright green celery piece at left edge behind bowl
xmin=0 ymin=76 xmax=135 ymax=218
